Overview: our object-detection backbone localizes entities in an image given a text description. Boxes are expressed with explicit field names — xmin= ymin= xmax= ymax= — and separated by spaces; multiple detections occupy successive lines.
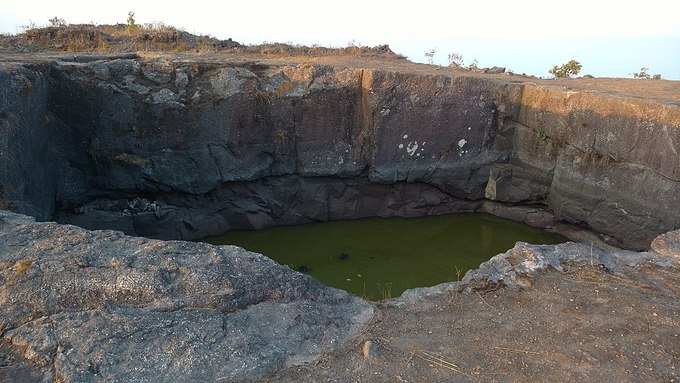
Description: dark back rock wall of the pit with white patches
xmin=49 ymin=59 xmax=507 ymax=239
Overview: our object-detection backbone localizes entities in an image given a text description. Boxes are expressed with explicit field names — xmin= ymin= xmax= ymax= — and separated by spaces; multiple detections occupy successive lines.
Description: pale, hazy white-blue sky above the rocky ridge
xmin=0 ymin=0 xmax=680 ymax=80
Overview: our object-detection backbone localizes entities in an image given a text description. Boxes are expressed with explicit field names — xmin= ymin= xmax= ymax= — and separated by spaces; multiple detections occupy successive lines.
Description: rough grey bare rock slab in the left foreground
xmin=0 ymin=211 xmax=373 ymax=382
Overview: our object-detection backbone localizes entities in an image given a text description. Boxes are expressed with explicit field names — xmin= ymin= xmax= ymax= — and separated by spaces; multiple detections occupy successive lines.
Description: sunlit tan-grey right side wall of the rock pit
xmin=486 ymin=86 xmax=680 ymax=249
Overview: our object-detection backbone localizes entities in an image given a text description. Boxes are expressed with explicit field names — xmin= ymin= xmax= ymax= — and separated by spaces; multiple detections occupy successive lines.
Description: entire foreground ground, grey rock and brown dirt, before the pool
xmin=0 ymin=212 xmax=680 ymax=382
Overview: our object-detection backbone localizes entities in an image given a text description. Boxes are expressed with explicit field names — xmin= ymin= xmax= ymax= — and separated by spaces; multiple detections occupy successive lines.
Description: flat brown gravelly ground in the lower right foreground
xmin=268 ymin=246 xmax=680 ymax=382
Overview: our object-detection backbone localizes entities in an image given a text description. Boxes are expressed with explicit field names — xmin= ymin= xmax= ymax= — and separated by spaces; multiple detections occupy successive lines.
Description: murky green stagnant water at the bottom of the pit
xmin=206 ymin=213 xmax=565 ymax=299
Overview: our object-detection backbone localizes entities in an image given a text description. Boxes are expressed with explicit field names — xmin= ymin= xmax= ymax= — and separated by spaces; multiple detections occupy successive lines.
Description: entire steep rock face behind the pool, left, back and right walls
xmin=0 ymin=59 xmax=680 ymax=248
